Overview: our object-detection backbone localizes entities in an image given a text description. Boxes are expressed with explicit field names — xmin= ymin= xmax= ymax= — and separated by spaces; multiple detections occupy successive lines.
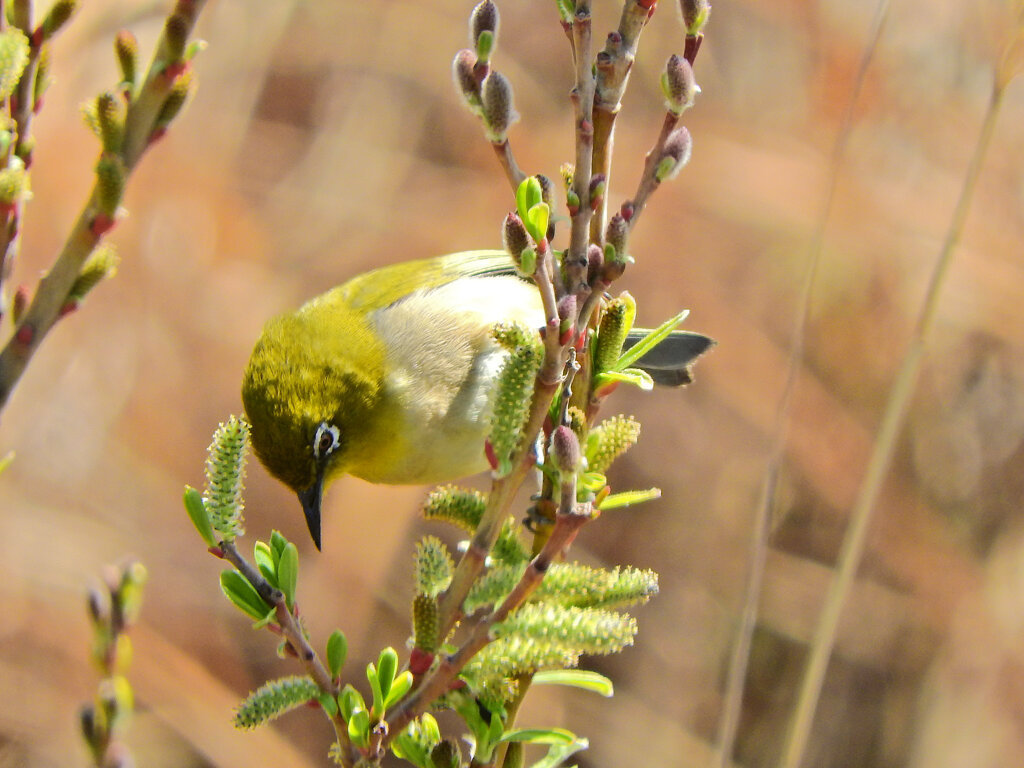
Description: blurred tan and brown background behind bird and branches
xmin=0 ymin=0 xmax=1024 ymax=768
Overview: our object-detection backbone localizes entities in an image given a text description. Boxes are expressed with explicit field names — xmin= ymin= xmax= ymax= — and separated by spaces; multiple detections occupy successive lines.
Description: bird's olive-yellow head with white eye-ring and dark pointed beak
xmin=242 ymin=294 xmax=385 ymax=549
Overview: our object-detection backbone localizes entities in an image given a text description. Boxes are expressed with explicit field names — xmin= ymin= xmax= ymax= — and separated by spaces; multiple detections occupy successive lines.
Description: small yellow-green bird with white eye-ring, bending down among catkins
xmin=242 ymin=251 xmax=712 ymax=549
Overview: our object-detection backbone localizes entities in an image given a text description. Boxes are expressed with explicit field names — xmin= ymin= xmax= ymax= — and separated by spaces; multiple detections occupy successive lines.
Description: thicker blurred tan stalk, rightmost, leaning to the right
xmin=779 ymin=78 xmax=1007 ymax=768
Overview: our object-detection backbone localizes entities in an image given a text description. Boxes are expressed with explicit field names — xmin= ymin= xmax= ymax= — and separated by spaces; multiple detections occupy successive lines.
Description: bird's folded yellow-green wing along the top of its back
xmin=340 ymin=251 xmax=515 ymax=311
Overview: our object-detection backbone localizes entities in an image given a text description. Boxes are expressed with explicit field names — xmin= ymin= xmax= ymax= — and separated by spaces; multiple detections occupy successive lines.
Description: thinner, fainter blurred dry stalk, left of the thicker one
xmin=717 ymin=0 xmax=889 ymax=768
